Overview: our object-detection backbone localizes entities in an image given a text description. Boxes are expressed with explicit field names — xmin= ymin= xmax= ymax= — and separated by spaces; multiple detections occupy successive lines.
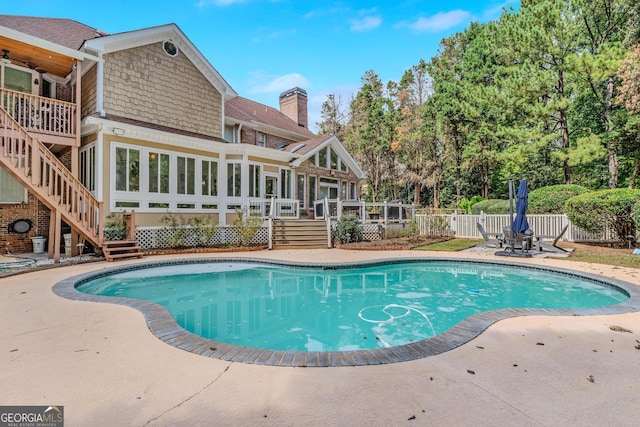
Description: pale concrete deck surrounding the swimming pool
xmin=0 ymin=249 xmax=640 ymax=427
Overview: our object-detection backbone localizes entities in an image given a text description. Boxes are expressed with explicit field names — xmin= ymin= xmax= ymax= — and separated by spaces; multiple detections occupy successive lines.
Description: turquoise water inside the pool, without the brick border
xmin=77 ymin=261 xmax=628 ymax=352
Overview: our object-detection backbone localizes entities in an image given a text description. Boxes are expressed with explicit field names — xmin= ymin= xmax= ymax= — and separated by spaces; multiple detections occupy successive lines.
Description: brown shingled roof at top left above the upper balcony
xmin=0 ymin=15 xmax=106 ymax=50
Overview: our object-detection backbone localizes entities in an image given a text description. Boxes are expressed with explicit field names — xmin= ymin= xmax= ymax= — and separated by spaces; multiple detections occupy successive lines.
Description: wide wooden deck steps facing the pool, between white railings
xmin=272 ymin=219 xmax=330 ymax=249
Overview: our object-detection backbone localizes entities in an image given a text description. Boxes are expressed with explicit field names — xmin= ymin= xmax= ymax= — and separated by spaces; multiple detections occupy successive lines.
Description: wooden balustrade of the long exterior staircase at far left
xmin=0 ymin=105 xmax=103 ymax=246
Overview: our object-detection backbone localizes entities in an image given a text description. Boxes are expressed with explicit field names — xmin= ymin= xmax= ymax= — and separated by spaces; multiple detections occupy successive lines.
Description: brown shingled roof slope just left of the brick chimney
xmin=224 ymin=96 xmax=316 ymax=138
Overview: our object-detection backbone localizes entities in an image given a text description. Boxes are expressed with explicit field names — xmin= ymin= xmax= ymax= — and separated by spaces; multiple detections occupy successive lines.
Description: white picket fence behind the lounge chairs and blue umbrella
xmin=416 ymin=212 xmax=617 ymax=242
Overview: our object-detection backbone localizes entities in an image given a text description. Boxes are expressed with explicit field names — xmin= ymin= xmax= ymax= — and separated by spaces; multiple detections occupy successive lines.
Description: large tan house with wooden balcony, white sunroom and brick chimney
xmin=0 ymin=15 xmax=364 ymax=259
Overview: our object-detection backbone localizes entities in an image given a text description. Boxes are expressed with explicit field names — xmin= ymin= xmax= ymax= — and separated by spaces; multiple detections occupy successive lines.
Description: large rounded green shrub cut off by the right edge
xmin=564 ymin=188 xmax=640 ymax=243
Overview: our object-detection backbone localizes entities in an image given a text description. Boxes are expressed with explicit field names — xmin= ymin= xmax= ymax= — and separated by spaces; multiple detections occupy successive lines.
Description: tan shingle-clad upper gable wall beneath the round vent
xmin=102 ymin=43 xmax=222 ymax=138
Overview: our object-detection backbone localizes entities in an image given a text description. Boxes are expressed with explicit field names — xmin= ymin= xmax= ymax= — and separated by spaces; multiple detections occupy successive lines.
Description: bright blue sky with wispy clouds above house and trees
xmin=0 ymin=0 xmax=519 ymax=130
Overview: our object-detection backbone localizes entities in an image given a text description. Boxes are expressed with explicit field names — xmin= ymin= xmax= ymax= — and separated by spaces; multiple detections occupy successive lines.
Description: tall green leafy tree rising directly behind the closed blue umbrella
xmin=496 ymin=0 xmax=577 ymax=183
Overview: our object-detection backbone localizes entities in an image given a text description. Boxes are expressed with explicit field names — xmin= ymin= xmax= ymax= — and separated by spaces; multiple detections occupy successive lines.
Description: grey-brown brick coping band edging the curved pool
xmin=52 ymin=258 xmax=640 ymax=367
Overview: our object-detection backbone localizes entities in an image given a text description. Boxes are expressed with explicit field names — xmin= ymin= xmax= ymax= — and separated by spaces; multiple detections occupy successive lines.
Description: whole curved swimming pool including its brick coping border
xmin=56 ymin=259 xmax=630 ymax=366
